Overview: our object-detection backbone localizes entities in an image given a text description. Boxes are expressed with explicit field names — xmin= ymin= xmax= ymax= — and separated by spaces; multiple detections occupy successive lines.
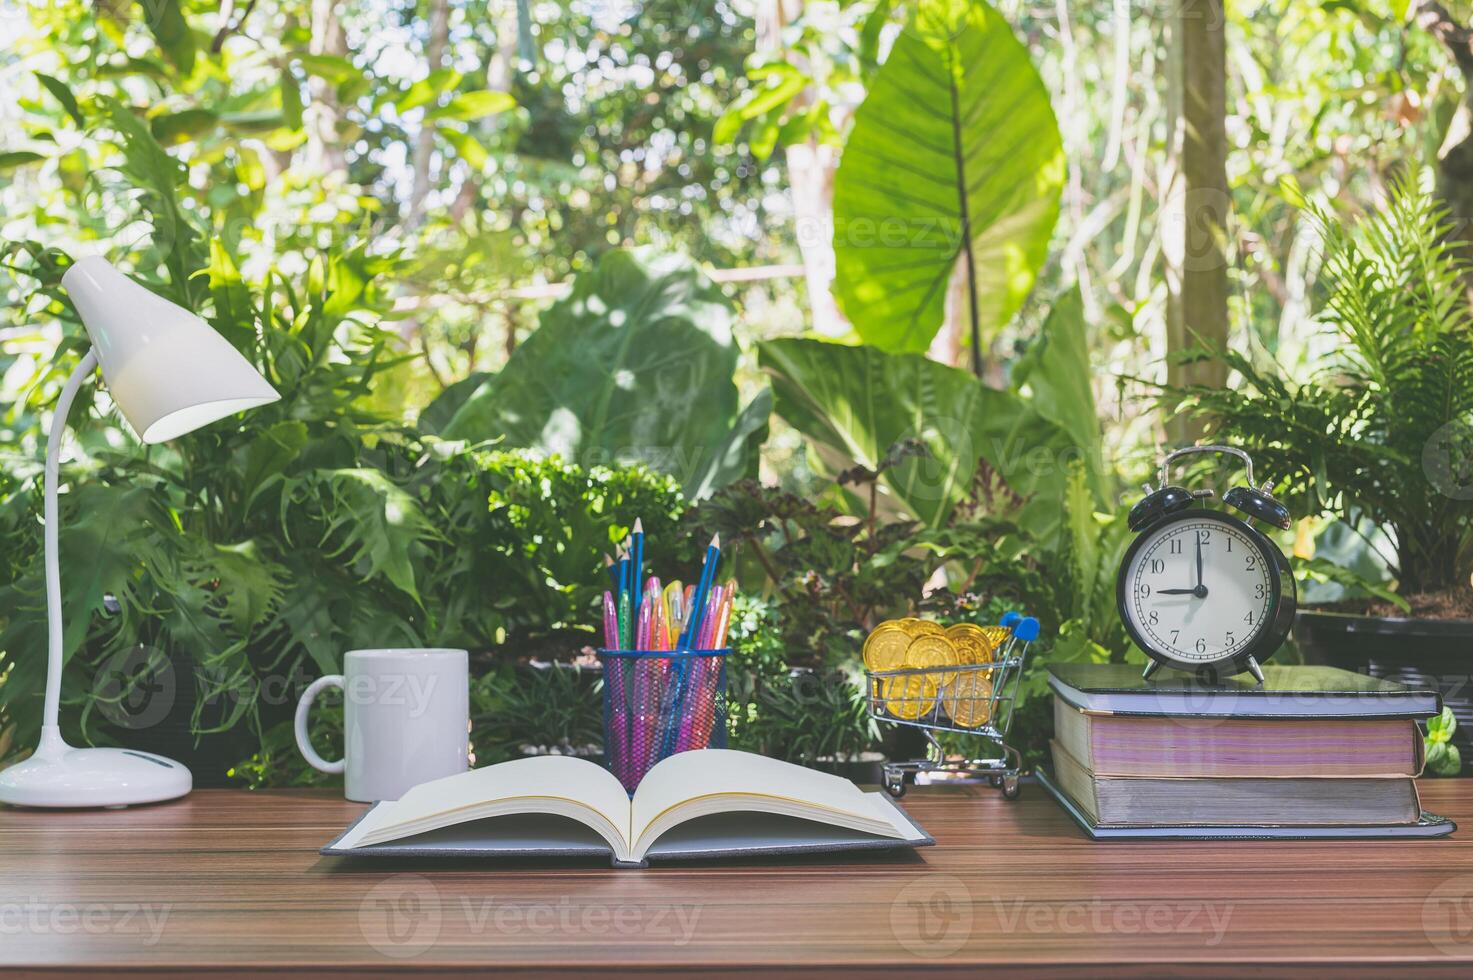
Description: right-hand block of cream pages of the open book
xmin=630 ymin=749 xmax=915 ymax=858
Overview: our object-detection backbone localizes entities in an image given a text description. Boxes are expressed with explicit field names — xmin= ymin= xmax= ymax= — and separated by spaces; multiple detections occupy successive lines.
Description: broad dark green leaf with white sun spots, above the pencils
xmin=440 ymin=251 xmax=751 ymax=492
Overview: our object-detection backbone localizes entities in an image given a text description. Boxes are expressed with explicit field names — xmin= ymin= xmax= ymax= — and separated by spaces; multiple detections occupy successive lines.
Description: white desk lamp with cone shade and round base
xmin=0 ymin=258 xmax=280 ymax=806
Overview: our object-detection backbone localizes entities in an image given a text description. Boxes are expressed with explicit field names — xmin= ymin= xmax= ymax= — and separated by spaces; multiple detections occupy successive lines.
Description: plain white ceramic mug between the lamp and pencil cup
xmin=296 ymin=650 xmax=470 ymax=803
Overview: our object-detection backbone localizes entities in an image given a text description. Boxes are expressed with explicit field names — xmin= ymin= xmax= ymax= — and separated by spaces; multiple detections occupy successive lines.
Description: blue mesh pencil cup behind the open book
xmin=598 ymin=650 xmax=729 ymax=793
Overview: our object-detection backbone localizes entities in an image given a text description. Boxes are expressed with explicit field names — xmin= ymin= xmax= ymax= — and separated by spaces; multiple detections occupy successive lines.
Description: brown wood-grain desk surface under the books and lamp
xmin=0 ymin=780 xmax=1473 ymax=977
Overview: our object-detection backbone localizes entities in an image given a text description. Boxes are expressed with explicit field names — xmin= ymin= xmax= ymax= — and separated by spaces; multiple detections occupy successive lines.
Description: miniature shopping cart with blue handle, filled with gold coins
xmin=866 ymin=613 xmax=1038 ymax=800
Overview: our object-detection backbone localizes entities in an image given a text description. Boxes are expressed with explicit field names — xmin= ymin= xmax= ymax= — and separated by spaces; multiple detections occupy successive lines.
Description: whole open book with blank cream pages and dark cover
xmin=323 ymin=749 xmax=935 ymax=865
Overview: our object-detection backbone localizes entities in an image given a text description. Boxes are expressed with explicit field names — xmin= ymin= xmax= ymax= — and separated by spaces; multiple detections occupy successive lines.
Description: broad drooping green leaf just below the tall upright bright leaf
xmin=759 ymin=339 xmax=1072 ymax=532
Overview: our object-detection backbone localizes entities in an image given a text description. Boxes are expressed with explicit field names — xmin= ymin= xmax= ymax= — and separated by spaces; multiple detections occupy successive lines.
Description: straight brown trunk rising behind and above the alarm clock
xmin=1161 ymin=0 xmax=1233 ymax=442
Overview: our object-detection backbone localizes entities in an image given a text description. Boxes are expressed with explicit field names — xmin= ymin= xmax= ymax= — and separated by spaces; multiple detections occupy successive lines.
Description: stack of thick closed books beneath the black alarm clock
xmin=1040 ymin=663 xmax=1454 ymax=839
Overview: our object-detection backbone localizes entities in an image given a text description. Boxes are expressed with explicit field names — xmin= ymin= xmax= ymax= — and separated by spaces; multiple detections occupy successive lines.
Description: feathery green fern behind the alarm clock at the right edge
xmin=1164 ymin=175 xmax=1473 ymax=595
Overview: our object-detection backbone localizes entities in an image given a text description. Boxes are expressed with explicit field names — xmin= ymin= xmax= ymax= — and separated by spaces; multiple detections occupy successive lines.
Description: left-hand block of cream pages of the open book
xmin=337 ymin=756 xmax=629 ymax=858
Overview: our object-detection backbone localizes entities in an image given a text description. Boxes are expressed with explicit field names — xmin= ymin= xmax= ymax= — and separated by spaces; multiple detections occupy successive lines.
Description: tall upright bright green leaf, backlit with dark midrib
xmin=834 ymin=0 xmax=1065 ymax=351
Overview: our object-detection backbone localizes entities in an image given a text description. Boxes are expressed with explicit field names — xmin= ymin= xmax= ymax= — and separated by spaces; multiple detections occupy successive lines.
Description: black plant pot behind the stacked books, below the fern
xmin=1293 ymin=610 xmax=1473 ymax=774
